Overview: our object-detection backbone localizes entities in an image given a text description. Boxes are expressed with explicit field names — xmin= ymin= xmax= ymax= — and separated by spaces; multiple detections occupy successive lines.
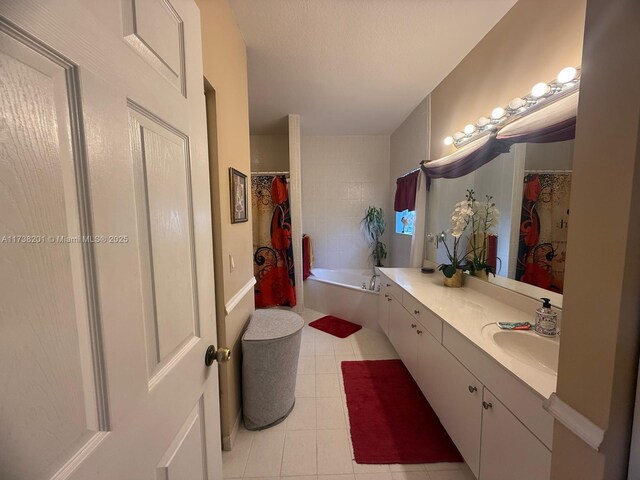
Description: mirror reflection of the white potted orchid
xmin=466 ymin=190 xmax=500 ymax=279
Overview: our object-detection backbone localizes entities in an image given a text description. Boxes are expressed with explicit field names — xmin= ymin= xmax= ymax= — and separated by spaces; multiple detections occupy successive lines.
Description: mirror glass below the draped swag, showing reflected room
xmin=426 ymin=140 xmax=574 ymax=294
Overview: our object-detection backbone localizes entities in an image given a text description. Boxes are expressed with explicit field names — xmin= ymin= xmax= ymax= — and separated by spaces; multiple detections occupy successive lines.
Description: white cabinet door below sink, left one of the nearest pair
xmin=431 ymin=347 xmax=480 ymax=480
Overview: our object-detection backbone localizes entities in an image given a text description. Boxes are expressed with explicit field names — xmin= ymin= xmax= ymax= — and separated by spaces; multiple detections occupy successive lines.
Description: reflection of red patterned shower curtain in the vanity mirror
xmin=516 ymin=173 xmax=571 ymax=293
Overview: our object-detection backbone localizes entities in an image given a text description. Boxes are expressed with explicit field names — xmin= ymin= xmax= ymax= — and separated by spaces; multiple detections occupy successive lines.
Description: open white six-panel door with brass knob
xmin=0 ymin=0 xmax=221 ymax=480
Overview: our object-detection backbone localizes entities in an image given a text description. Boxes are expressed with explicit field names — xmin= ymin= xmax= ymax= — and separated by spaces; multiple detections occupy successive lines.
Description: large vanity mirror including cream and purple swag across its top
xmin=423 ymin=85 xmax=578 ymax=307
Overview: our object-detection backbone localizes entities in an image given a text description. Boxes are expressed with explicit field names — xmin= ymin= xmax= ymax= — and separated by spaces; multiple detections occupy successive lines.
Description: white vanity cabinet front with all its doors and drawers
xmin=380 ymin=270 xmax=553 ymax=480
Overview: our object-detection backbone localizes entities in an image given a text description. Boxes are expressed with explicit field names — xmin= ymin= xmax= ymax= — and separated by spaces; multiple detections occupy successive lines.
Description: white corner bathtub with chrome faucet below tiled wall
xmin=304 ymin=268 xmax=380 ymax=331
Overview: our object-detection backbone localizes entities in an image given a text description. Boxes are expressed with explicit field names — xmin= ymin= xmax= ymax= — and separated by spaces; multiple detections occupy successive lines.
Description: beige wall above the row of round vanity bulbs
xmin=430 ymin=0 xmax=586 ymax=159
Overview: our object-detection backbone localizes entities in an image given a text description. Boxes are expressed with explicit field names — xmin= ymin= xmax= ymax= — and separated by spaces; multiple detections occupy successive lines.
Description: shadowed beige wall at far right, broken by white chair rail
xmin=552 ymin=0 xmax=640 ymax=480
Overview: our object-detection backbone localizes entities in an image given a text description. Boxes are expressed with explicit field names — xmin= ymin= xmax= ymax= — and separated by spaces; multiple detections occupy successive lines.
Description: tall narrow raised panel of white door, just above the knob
xmin=130 ymin=102 xmax=199 ymax=372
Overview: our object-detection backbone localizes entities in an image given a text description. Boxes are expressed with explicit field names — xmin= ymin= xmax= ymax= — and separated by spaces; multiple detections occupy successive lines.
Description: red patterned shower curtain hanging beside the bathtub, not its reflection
xmin=251 ymin=175 xmax=296 ymax=308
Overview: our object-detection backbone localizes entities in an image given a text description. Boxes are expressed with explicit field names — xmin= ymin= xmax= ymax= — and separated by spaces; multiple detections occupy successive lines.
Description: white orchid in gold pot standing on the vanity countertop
xmin=436 ymin=198 xmax=473 ymax=287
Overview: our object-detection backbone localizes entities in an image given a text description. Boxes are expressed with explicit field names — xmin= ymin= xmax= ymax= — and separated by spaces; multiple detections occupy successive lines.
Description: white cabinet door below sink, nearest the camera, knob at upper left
xmin=479 ymin=388 xmax=551 ymax=480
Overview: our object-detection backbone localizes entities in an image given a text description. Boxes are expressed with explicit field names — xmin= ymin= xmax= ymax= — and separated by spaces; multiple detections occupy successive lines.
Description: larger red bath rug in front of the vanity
xmin=342 ymin=360 xmax=463 ymax=464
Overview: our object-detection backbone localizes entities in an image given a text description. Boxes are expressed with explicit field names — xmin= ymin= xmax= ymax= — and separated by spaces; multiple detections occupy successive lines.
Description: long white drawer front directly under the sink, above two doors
xmin=442 ymin=325 xmax=553 ymax=449
